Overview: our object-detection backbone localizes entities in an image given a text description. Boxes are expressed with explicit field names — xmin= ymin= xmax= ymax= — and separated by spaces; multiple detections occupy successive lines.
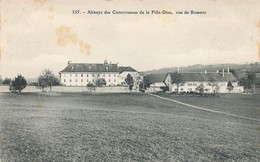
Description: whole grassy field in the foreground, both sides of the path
xmin=0 ymin=93 xmax=260 ymax=162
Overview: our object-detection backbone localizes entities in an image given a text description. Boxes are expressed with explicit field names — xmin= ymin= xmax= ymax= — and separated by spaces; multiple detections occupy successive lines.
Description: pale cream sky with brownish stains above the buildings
xmin=0 ymin=0 xmax=260 ymax=78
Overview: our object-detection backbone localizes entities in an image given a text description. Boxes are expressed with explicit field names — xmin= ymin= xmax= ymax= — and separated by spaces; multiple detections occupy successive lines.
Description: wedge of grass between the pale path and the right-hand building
xmin=160 ymin=93 xmax=260 ymax=120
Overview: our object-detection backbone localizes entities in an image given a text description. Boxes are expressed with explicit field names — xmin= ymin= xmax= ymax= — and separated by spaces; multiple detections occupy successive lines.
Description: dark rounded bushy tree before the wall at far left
xmin=9 ymin=75 xmax=27 ymax=93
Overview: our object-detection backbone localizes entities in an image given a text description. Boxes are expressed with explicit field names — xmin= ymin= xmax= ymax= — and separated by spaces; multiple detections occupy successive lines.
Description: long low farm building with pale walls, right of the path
xmin=164 ymin=70 xmax=244 ymax=93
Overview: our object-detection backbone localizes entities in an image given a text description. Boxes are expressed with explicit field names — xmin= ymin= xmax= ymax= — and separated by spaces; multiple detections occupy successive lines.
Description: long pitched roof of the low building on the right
xmin=169 ymin=73 xmax=238 ymax=82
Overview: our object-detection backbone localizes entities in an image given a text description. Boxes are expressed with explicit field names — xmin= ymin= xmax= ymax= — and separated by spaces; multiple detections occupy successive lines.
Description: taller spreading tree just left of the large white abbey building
xmin=38 ymin=69 xmax=59 ymax=91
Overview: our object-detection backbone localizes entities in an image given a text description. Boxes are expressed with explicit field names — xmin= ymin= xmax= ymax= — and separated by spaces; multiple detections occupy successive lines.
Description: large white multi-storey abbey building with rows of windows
xmin=59 ymin=60 xmax=143 ymax=88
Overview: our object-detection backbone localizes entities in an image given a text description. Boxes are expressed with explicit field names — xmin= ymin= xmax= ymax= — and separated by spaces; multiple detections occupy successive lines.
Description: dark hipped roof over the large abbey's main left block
xmin=60 ymin=63 xmax=118 ymax=72
